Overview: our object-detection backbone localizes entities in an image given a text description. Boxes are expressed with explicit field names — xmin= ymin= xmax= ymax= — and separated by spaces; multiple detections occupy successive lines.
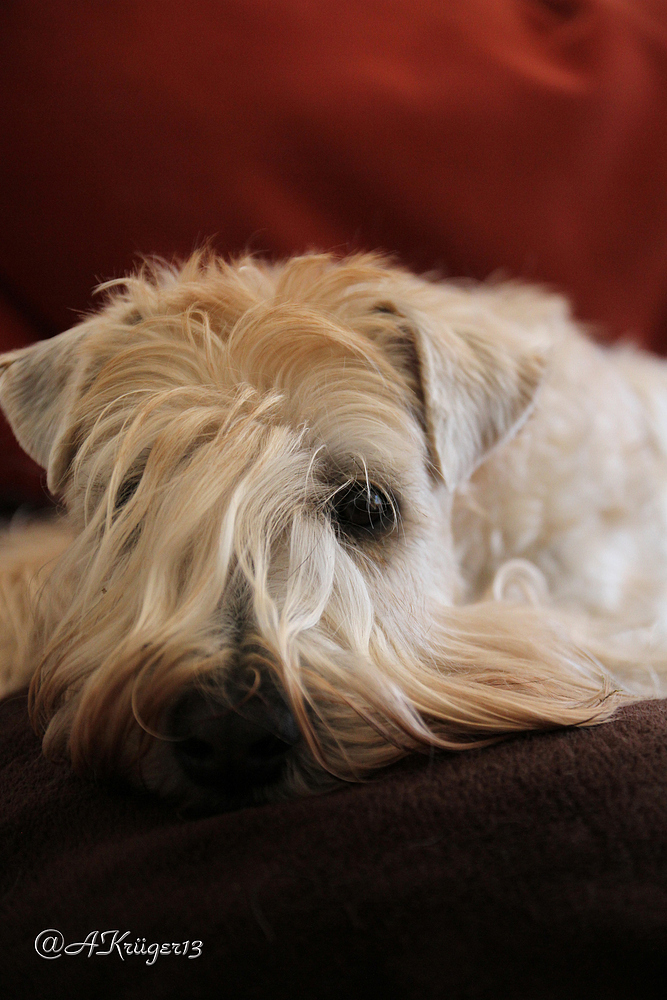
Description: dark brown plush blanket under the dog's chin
xmin=0 ymin=697 xmax=667 ymax=1000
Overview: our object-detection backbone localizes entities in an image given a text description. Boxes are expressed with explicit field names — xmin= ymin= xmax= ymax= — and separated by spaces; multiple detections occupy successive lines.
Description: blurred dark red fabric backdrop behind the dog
xmin=0 ymin=0 xmax=667 ymax=496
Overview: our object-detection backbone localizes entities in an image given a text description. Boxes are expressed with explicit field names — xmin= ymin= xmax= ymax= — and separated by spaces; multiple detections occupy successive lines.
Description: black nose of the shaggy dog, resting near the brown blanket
xmin=170 ymin=689 xmax=299 ymax=795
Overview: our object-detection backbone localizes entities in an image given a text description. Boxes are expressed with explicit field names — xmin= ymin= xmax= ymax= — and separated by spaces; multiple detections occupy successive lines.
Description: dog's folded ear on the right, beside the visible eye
xmin=380 ymin=286 xmax=562 ymax=489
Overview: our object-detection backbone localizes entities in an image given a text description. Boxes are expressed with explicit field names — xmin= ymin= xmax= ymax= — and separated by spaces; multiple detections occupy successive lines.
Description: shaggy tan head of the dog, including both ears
xmin=0 ymin=255 xmax=616 ymax=808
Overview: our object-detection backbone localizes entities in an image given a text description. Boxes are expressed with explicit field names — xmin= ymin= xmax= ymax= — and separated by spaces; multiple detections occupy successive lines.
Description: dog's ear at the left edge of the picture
xmin=0 ymin=327 xmax=85 ymax=490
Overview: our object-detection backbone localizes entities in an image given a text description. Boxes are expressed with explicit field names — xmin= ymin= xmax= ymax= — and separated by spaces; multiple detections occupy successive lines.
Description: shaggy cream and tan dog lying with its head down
xmin=0 ymin=252 xmax=667 ymax=811
